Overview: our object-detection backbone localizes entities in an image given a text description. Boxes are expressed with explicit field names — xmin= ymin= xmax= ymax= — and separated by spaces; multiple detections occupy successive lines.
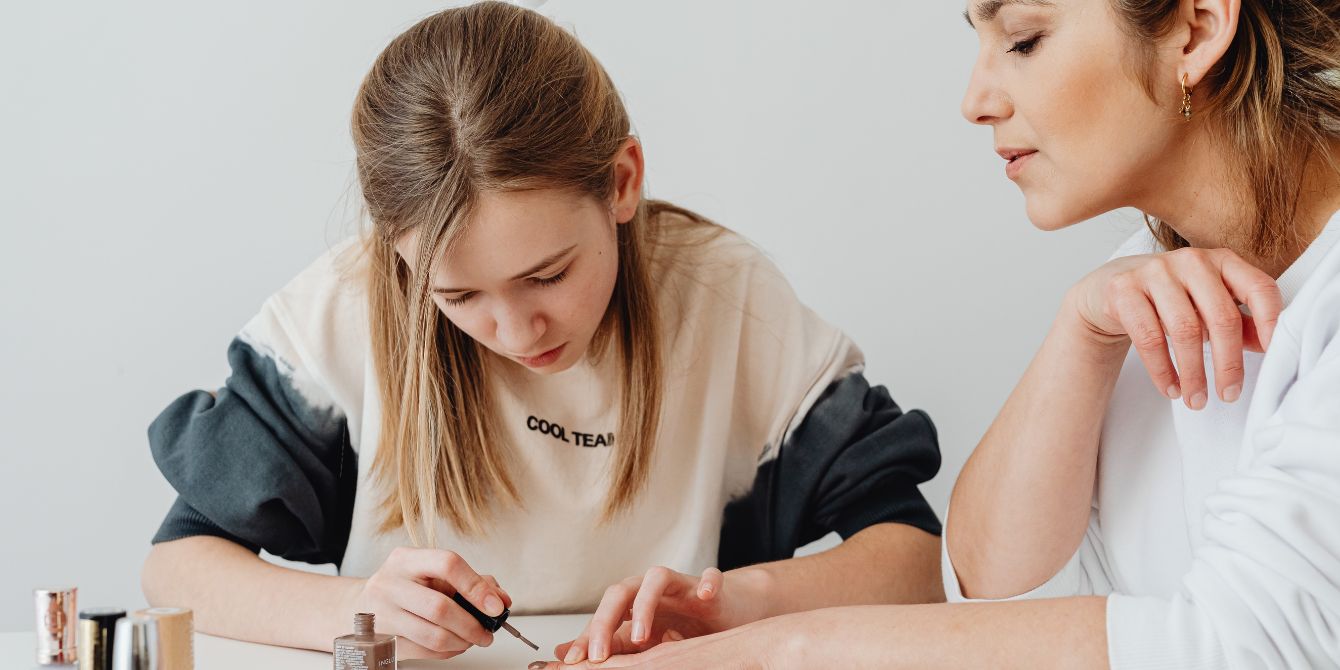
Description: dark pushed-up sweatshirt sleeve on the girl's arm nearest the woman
xmin=717 ymin=373 xmax=941 ymax=570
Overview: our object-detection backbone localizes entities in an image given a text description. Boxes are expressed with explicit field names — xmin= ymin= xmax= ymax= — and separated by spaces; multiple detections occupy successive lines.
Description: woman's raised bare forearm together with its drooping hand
xmin=945 ymin=248 xmax=1282 ymax=598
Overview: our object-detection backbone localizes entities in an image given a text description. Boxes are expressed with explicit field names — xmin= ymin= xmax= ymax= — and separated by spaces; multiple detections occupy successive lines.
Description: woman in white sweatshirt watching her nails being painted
xmin=549 ymin=0 xmax=1340 ymax=669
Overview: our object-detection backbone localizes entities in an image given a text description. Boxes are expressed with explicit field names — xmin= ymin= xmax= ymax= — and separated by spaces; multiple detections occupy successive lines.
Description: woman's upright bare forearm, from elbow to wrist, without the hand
xmin=946 ymin=297 xmax=1128 ymax=598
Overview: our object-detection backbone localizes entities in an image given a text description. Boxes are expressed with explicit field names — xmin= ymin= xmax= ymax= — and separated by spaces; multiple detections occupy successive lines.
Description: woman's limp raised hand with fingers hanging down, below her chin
xmin=1067 ymin=248 xmax=1284 ymax=410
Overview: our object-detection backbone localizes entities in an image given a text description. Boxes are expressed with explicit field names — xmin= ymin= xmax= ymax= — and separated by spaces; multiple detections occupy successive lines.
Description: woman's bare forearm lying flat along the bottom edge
xmin=795 ymin=596 xmax=1108 ymax=670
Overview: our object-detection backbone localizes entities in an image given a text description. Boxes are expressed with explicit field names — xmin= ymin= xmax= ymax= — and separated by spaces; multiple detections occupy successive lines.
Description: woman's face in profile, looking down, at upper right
xmin=962 ymin=0 xmax=1186 ymax=230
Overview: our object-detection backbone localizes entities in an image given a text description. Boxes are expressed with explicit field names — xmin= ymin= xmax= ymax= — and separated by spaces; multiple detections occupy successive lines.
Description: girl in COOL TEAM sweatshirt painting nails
xmin=143 ymin=3 xmax=939 ymax=657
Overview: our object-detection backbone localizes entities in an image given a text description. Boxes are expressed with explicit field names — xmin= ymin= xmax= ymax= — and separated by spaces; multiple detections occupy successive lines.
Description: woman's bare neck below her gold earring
xmin=1135 ymin=138 xmax=1340 ymax=277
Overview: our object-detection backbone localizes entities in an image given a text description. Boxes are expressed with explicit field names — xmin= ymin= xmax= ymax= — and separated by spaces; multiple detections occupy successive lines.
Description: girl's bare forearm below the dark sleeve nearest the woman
xmin=726 ymin=523 xmax=945 ymax=616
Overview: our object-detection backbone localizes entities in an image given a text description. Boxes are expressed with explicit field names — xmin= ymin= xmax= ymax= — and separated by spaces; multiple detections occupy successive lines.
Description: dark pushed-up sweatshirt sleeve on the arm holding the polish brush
xmin=149 ymin=339 xmax=358 ymax=564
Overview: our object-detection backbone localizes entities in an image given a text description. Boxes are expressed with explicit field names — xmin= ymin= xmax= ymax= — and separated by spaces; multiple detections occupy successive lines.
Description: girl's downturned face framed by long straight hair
xmin=395 ymin=189 xmax=619 ymax=374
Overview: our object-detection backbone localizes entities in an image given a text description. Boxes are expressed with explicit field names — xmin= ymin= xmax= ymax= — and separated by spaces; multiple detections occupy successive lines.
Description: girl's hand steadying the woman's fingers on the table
xmin=553 ymin=567 xmax=765 ymax=663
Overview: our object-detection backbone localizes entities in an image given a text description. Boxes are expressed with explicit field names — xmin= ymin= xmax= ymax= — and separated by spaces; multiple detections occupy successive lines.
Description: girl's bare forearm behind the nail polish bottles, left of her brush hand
xmin=142 ymin=536 xmax=360 ymax=651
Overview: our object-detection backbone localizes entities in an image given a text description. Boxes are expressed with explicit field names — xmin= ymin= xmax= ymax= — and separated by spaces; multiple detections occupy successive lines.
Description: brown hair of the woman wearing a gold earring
xmin=1112 ymin=0 xmax=1340 ymax=260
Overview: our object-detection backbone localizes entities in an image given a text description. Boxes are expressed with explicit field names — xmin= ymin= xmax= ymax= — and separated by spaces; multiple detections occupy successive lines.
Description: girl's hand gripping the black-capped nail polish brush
xmin=342 ymin=547 xmax=512 ymax=658
